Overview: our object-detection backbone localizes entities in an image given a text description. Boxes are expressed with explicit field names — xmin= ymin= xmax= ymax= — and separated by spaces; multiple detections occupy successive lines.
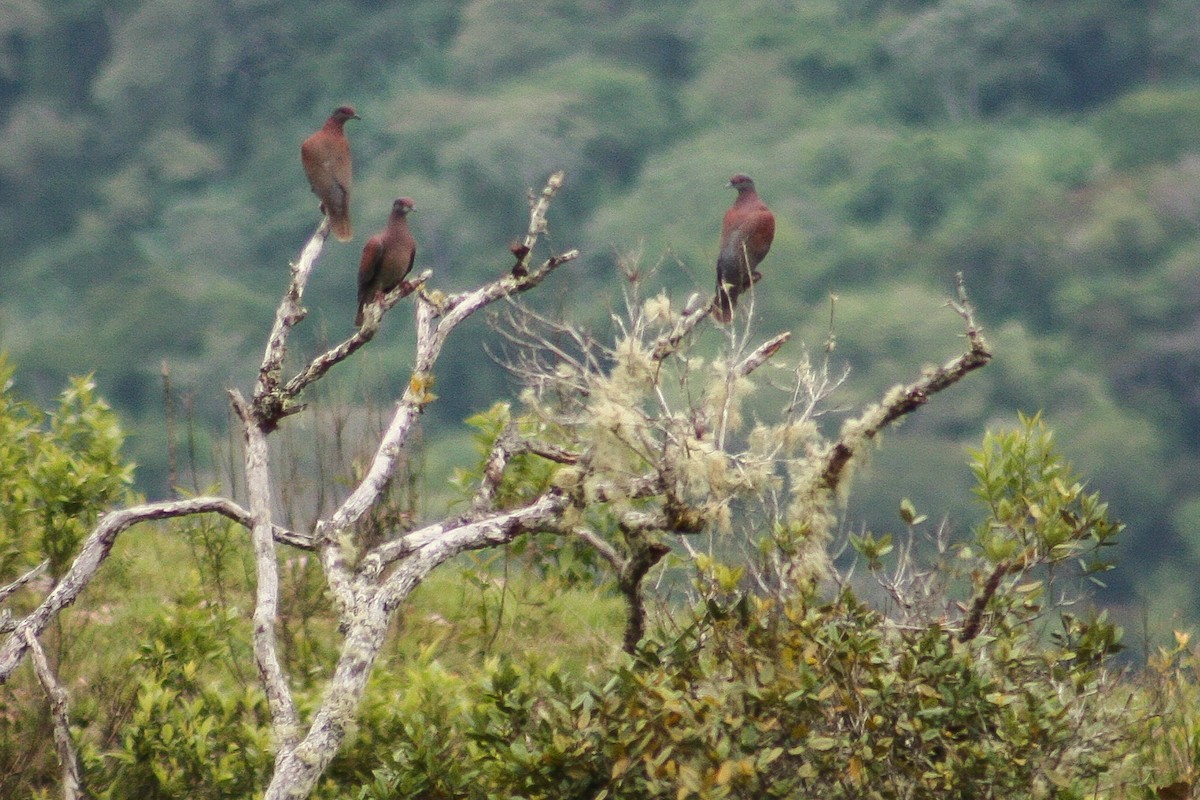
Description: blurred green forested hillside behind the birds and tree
xmin=0 ymin=0 xmax=1200 ymax=614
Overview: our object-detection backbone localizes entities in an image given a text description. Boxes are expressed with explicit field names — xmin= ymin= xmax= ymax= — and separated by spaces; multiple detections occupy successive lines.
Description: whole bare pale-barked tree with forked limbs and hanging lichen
xmin=0 ymin=173 xmax=990 ymax=799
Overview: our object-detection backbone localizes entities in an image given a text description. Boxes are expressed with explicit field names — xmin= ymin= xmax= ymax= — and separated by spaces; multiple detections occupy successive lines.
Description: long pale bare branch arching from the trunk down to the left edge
xmin=0 ymin=497 xmax=300 ymax=684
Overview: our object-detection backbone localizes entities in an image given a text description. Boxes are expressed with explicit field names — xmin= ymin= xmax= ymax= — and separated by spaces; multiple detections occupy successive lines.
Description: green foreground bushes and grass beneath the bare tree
xmin=0 ymin=359 xmax=1200 ymax=800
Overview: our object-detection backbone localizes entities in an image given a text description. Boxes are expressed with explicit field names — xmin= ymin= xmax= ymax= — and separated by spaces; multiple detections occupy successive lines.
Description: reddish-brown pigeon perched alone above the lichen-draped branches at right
xmin=713 ymin=174 xmax=775 ymax=323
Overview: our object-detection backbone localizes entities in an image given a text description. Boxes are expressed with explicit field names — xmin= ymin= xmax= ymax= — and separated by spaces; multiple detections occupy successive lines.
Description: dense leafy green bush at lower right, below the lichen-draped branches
xmin=359 ymin=417 xmax=1130 ymax=800
